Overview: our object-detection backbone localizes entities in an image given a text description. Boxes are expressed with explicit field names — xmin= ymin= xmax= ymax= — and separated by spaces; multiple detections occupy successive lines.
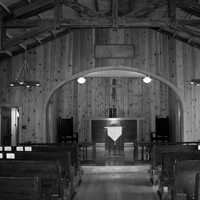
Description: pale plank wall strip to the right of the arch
xmin=176 ymin=42 xmax=200 ymax=141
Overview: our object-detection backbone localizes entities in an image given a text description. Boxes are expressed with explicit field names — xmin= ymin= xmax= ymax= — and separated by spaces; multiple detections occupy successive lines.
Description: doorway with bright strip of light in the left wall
xmin=0 ymin=106 xmax=20 ymax=146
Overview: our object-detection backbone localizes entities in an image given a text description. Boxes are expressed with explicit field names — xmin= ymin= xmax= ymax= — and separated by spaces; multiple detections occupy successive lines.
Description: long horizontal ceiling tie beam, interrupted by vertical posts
xmin=5 ymin=17 xmax=169 ymax=28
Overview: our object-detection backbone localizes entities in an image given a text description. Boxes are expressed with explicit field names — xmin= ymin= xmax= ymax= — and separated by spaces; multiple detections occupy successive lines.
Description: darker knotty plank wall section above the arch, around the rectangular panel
xmin=73 ymin=29 xmax=171 ymax=79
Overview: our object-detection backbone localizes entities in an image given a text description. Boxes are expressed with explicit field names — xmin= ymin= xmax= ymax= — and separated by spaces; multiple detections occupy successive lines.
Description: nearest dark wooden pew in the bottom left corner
xmin=0 ymin=177 xmax=42 ymax=200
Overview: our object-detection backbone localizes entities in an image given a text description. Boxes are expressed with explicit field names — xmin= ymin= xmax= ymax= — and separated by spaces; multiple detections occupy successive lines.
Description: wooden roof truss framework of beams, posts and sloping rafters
xmin=2 ymin=0 xmax=200 ymax=55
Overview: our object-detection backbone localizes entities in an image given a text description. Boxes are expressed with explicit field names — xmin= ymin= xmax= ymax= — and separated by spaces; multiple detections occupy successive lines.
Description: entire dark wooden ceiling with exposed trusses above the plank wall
xmin=0 ymin=0 xmax=200 ymax=56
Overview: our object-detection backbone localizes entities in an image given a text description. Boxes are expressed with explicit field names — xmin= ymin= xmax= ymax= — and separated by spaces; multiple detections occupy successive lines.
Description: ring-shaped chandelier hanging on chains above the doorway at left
xmin=9 ymin=48 xmax=40 ymax=89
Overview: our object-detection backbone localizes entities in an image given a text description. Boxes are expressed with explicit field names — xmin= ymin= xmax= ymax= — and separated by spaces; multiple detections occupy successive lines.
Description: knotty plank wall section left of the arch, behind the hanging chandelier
xmin=0 ymin=34 xmax=73 ymax=142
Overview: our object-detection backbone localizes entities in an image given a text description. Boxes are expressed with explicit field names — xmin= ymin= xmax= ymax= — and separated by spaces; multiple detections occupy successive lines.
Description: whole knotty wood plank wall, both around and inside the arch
xmin=0 ymin=29 xmax=200 ymax=142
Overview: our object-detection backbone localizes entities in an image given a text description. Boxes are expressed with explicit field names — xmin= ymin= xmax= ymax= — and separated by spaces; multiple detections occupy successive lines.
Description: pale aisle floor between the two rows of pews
xmin=74 ymin=165 xmax=157 ymax=200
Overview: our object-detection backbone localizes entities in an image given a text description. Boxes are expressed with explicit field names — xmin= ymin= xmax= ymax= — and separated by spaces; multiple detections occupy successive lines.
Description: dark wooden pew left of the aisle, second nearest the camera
xmin=0 ymin=160 xmax=64 ymax=200
